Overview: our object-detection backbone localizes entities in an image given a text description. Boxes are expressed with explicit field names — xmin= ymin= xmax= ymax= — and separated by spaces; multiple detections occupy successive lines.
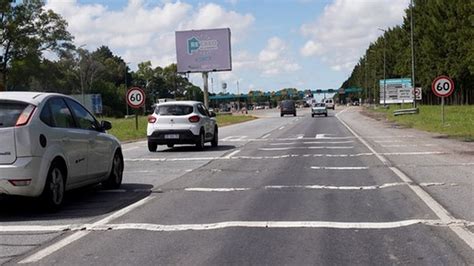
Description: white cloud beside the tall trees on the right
xmin=300 ymin=0 xmax=409 ymax=71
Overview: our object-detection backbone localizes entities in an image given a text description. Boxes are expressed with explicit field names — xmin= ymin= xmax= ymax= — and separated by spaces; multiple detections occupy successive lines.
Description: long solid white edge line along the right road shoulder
xmin=336 ymin=109 xmax=474 ymax=249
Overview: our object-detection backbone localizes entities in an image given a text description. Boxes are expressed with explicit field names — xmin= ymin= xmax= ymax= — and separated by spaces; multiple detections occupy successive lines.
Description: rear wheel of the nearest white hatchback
xmin=41 ymin=163 xmax=66 ymax=211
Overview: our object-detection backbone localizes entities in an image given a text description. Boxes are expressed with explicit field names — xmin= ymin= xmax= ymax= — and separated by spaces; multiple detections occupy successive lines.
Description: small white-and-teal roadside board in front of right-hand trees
xmin=379 ymin=78 xmax=413 ymax=104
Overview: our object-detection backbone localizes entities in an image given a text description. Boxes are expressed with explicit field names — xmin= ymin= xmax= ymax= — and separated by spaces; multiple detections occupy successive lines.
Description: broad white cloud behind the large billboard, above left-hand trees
xmin=46 ymin=0 xmax=255 ymax=66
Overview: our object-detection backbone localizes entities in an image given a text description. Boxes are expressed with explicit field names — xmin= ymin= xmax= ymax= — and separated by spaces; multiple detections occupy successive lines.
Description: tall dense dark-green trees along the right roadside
xmin=341 ymin=0 xmax=474 ymax=105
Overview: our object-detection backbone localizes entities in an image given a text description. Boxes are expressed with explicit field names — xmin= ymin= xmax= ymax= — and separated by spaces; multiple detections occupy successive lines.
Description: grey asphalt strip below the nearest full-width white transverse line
xmin=35 ymin=225 xmax=474 ymax=265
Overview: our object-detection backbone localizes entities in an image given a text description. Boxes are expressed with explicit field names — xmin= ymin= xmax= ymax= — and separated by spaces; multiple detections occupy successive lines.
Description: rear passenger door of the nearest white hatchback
xmin=40 ymin=97 xmax=88 ymax=188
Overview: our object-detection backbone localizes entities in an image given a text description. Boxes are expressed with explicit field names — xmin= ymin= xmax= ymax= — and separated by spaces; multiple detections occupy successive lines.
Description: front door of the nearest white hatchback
xmin=66 ymin=98 xmax=113 ymax=182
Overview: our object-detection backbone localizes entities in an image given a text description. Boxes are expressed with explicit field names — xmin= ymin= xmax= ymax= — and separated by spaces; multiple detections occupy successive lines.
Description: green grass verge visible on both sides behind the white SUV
xmin=106 ymin=115 xmax=256 ymax=141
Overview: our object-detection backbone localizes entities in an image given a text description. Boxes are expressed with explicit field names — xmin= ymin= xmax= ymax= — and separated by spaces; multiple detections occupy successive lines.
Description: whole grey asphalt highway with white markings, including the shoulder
xmin=0 ymin=108 xmax=474 ymax=265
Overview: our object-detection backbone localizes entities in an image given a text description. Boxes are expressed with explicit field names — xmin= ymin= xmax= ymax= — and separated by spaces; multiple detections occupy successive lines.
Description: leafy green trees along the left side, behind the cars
xmin=0 ymin=0 xmax=203 ymax=116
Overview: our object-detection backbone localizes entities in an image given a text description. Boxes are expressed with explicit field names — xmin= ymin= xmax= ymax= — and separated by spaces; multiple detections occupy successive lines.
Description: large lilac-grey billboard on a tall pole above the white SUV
xmin=175 ymin=28 xmax=232 ymax=73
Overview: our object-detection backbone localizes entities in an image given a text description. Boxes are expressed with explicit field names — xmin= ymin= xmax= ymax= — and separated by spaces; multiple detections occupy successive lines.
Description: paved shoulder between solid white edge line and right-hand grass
xmin=340 ymin=109 xmax=474 ymax=221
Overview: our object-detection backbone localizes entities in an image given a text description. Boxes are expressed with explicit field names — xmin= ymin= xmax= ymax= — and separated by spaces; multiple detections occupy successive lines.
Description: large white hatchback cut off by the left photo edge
xmin=0 ymin=92 xmax=123 ymax=210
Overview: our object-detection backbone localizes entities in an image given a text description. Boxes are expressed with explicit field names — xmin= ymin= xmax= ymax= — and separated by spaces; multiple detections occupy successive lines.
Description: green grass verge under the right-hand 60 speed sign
xmin=370 ymin=105 xmax=474 ymax=141
